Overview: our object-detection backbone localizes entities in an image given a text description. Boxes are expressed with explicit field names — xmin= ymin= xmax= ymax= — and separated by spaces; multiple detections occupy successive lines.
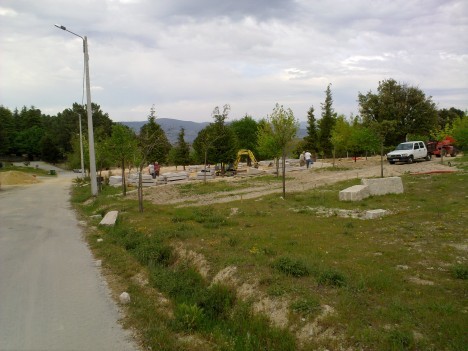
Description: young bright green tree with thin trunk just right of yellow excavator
xmin=258 ymin=104 xmax=299 ymax=198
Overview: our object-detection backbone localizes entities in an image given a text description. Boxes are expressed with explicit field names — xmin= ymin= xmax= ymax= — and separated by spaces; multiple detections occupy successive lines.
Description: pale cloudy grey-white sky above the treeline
xmin=0 ymin=0 xmax=468 ymax=122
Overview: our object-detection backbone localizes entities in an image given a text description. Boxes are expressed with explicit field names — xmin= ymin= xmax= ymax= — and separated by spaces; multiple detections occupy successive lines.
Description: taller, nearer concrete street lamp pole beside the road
xmin=55 ymin=24 xmax=98 ymax=196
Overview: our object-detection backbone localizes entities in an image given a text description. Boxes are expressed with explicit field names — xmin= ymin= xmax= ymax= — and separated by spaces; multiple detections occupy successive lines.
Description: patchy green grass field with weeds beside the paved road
xmin=73 ymin=158 xmax=468 ymax=350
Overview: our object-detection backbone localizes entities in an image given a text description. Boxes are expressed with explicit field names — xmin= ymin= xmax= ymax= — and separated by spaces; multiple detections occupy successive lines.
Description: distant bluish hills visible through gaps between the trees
xmin=120 ymin=118 xmax=307 ymax=144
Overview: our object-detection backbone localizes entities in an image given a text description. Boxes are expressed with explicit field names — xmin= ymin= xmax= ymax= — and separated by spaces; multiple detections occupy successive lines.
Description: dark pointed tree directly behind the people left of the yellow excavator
xmin=140 ymin=106 xmax=172 ymax=164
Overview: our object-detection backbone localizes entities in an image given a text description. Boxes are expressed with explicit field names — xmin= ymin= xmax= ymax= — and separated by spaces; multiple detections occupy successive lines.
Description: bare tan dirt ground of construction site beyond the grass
xmin=135 ymin=156 xmax=456 ymax=207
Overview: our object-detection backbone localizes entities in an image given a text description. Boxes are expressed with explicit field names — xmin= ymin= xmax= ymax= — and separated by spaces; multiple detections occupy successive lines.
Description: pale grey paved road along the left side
xmin=0 ymin=169 xmax=137 ymax=351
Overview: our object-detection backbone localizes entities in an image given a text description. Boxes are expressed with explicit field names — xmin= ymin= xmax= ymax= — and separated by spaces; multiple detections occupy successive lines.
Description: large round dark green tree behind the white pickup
xmin=358 ymin=79 xmax=437 ymax=145
